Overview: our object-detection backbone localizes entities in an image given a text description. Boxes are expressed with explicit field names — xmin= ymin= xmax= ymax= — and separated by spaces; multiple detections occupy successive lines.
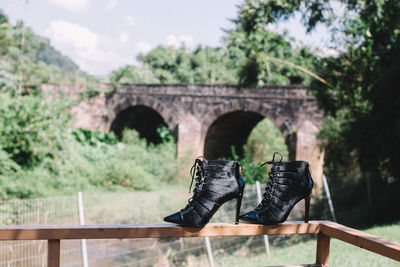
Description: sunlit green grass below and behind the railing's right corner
xmin=211 ymin=222 xmax=400 ymax=267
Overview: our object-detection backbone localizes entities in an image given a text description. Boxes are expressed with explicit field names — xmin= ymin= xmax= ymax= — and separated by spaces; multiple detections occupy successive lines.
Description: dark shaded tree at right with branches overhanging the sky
xmin=236 ymin=0 xmax=400 ymax=176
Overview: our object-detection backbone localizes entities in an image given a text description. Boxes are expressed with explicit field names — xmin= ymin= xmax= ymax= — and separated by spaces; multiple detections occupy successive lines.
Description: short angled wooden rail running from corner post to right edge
xmin=321 ymin=221 xmax=400 ymax=261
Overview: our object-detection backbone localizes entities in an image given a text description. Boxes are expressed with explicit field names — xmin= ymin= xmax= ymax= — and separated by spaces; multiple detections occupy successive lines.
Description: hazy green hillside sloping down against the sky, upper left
xmin=0 ymin=10 xmax=92 ymax=91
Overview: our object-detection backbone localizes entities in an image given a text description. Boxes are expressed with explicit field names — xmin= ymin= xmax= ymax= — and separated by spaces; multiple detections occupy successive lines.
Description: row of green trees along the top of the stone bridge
xmin=109 ymin=37 xmax=315 ymax=86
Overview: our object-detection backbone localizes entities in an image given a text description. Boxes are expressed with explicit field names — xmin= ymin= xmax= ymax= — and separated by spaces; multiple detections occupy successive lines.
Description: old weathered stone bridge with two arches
xmin=42 ymin=84 xmax=323 ymax=191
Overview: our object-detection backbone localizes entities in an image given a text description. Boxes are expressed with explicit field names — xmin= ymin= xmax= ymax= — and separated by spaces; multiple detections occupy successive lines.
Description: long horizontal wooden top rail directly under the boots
xmin=0 ymin=221 xmax=319 ymax=240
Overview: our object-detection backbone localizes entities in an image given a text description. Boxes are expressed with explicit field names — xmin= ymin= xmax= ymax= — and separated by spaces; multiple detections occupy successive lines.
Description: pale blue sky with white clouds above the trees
xmin=0 ymin=0 xmax=328 ymax=75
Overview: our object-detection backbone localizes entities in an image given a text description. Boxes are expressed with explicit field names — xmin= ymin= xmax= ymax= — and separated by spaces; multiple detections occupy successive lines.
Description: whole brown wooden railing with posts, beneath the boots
xmin=0 ymin=221 xmax=400 ymax=267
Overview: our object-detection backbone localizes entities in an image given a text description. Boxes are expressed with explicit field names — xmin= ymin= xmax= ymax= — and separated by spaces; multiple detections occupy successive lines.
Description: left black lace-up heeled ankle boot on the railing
xmin=164 ymin=157 xmax=244 ymax=226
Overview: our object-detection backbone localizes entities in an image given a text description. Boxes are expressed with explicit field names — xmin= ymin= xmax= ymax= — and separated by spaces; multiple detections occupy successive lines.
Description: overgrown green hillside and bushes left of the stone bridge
xmin=0 ymin=11 xmax=177 ymax=200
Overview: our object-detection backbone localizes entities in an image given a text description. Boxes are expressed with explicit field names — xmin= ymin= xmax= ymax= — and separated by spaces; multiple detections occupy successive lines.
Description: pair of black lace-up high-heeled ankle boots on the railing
xmin=164 ymin=152 xmax=314 ymax=226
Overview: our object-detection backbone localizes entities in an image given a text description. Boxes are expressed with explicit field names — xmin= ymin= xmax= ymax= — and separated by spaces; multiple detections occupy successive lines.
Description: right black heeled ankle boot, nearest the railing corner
xmin=240 ymin=152 xmax=314 ymax=224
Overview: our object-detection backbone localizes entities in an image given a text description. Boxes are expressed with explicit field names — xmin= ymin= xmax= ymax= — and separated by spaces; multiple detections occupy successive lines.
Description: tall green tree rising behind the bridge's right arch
xmin=225 ymin=0 xmax=322 ymax=86
